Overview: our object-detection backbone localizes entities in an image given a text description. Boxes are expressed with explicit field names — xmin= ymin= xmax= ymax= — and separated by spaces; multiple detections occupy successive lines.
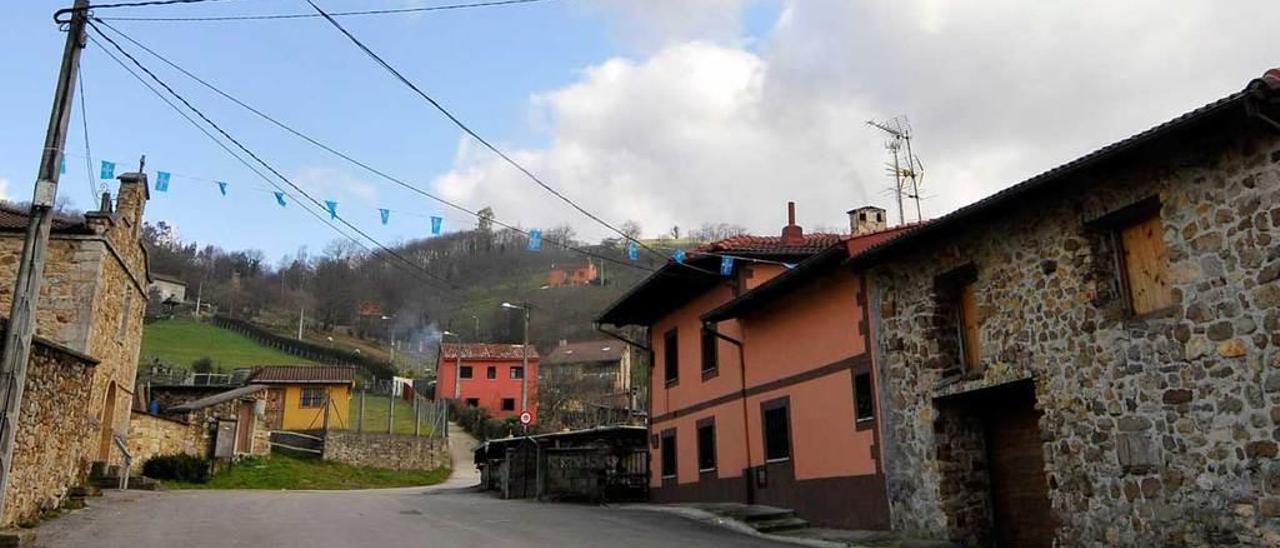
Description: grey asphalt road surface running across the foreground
xmin=36 ymin=488 xmax=782 ymax=548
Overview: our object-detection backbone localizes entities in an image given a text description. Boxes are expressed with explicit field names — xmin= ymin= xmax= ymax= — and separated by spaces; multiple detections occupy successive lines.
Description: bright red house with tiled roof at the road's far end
xmin=435 ymin=343 xmax=538 ymax=421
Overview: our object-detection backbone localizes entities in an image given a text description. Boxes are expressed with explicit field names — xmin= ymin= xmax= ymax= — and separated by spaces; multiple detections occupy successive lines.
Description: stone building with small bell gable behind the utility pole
xmin=0 ymin=173 xmax=150 ymax=526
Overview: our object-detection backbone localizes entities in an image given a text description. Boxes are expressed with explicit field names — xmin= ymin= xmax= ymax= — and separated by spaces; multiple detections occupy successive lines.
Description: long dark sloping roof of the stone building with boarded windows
xmin=854 ymin=69 xmax=1280 ymax=270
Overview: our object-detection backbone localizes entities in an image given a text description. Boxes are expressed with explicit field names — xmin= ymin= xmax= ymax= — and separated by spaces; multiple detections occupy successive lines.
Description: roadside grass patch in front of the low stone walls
xmin=164 ymin=453 xmax=449 ymax=490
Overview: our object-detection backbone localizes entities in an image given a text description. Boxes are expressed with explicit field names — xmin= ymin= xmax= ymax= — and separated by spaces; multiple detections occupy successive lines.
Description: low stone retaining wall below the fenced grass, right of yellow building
xmin=324 ymin=430 xmax=449 ymax=470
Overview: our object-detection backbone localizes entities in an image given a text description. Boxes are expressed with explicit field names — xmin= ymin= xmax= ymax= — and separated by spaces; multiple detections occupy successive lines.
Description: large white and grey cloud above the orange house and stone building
xmin=435 ymin=0 xmax=1280 ymax=236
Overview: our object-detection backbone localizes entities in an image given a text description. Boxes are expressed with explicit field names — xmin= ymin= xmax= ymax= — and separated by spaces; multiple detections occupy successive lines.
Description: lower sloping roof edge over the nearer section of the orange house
xmin=701 ymin=224 xmax=919 ymax=321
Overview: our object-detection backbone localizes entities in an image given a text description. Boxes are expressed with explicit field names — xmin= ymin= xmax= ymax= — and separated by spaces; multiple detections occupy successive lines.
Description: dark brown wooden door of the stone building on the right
xmin=987 ymin=402 xmax=1056 ymax=548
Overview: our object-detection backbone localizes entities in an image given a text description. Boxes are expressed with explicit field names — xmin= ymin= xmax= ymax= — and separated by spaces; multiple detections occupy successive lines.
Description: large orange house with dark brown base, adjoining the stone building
xmin=599 ymin=203 xmax=896 ymax=529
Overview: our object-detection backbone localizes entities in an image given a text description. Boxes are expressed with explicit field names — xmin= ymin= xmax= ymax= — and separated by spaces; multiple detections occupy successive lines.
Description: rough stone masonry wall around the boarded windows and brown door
xmin=868 ymin=115 xmax=1280 ymax=545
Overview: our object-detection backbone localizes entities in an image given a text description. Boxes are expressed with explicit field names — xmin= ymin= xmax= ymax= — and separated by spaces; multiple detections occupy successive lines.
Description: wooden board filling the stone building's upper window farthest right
xmin=1120 ymin=216 xmax=1174 ymax=314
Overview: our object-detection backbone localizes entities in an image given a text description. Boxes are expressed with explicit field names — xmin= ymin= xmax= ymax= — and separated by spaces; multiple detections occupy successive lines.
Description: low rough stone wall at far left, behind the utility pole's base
xmin=0 ymin=338 xmax=95 ymax=528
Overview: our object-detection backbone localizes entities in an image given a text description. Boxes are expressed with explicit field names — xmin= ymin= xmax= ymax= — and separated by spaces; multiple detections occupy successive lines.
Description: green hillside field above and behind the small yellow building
xmin=138 ymin=319 xmax=315 ymax=371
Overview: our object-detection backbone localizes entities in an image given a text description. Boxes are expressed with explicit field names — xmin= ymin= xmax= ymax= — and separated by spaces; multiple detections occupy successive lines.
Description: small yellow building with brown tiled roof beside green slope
xmin=248 ymin=365 xmax=356 ymax=430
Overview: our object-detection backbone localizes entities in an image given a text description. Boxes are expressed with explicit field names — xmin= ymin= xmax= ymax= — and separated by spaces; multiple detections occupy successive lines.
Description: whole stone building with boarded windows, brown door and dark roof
xmin=852 ymin=70 xmax=1280 ymax=547
